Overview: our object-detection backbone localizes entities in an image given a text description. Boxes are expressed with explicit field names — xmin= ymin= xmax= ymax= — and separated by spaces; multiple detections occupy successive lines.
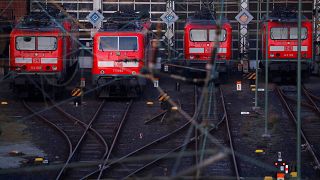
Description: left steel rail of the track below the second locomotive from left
xmin=56 ymin=100 xmax=106 ymax=180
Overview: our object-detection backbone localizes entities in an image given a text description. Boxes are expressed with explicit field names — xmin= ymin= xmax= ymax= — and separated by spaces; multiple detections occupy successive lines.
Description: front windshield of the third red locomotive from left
xmin=190 ymin=29 xmax=227 ymax=42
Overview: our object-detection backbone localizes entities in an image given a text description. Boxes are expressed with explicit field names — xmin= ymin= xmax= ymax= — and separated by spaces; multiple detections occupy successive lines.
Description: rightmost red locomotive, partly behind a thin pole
xmin=262 ymin=9 xmax=312 ymax=78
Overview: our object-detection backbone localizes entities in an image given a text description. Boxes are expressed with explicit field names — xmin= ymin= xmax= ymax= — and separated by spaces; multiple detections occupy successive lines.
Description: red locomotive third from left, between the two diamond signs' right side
xmin=184 ymin=10 xmax=232 ymax=72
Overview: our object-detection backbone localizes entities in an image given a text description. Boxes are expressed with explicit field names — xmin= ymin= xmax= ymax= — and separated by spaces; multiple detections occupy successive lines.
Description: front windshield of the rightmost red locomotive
xmin=270 ymin=27 xmax=308 ymax=40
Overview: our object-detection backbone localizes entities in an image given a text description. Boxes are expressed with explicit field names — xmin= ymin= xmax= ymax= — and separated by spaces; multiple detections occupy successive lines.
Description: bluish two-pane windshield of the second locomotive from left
xmin=99 ymin=36 xmax=138 ymax=51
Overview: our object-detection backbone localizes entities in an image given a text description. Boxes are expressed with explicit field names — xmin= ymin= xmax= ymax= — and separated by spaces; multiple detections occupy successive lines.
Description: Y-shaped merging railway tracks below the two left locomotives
xmin=23 ymin=101 xmax=133 ymax=179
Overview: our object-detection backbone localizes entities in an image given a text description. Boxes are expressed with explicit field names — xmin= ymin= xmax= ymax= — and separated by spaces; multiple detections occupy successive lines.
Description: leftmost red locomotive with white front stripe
xmin=10 ymin=5 xmax=78 ymax=96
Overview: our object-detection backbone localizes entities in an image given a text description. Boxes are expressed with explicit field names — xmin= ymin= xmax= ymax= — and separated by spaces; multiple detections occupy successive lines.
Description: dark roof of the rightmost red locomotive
xmin=262 ymin=8 xmax=307 ymax=22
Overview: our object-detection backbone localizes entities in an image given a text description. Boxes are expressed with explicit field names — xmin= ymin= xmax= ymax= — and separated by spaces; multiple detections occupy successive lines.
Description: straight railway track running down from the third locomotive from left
xmin=190 ymin=87 xmax=240 ymax=179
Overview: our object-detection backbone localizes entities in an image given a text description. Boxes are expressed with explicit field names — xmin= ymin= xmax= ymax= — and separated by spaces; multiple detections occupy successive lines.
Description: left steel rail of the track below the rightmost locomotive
xmin=276 ymin=87 xmax=320 ymax=167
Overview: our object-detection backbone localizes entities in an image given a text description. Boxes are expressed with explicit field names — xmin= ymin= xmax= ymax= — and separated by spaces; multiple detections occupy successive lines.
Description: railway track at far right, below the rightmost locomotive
xmin=276 ymin=86 xmax=320 ymax=169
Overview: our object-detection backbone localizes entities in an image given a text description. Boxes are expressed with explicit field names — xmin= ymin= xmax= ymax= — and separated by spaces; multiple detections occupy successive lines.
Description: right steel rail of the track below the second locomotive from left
xmin=97 ymin=100 xmax=133 ymax=179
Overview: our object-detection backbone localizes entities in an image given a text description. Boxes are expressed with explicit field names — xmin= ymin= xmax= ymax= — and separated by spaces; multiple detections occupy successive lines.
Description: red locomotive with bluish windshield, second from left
xmin=92 ymin=12 xmax=150 ymax=97
